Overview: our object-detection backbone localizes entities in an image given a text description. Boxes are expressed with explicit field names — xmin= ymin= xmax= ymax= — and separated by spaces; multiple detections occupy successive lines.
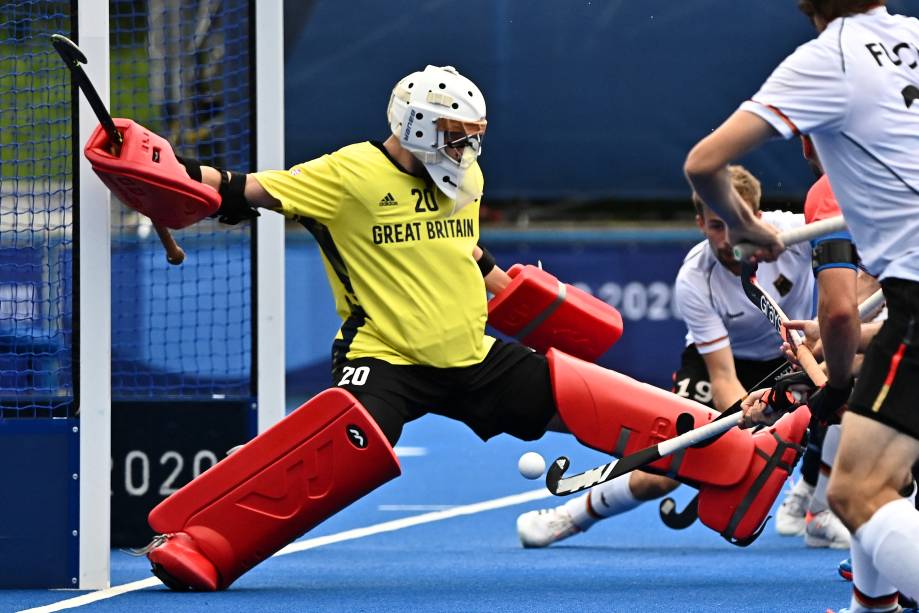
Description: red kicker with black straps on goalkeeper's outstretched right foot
xmin=699 ymin=406 xmax=811 ymax=546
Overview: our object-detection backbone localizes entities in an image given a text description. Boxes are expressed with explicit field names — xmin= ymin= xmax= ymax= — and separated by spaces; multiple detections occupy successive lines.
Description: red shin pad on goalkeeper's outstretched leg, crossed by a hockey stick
xmin=546 ymin=349 xmax=753 ymax=486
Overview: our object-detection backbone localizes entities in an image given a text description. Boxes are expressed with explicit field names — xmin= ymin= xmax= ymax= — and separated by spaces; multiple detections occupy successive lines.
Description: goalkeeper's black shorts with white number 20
xmin=332 ymin=340 xmax=556 ymax=444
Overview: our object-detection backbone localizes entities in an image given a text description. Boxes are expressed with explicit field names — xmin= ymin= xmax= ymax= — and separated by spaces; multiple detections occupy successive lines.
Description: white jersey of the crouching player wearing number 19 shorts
xmin=674 ymin=211 xmax=814 ymax=360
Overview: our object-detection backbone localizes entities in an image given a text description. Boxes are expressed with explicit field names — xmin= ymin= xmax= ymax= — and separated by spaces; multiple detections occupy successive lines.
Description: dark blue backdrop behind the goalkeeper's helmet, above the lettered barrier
xmin=286 ymin=0 xmax=917 ymax=199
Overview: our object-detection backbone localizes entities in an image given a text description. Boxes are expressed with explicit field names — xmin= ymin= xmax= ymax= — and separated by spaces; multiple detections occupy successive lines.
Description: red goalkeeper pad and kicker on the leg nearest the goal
xmin=148 ymin=388 xmax=401 ymax=590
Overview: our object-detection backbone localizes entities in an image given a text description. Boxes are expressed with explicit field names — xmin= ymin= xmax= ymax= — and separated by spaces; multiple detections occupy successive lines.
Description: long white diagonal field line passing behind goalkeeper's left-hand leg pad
xmin=18 ymin=488 xmax=552 ymax=613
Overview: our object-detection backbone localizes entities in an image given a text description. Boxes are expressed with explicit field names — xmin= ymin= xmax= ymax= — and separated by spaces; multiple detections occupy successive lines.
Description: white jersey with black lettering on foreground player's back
xmin=740 ymin=7 xmax=919 ymax=281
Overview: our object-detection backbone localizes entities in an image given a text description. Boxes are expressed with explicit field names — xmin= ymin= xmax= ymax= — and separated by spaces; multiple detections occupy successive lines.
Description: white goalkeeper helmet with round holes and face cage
xmin=386 ymin=66 xmax=486 ymax=213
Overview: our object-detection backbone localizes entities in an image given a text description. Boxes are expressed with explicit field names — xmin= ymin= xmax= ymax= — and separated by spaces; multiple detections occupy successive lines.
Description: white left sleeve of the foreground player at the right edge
xmin=740 ymin=33 xmax=849 ymax=139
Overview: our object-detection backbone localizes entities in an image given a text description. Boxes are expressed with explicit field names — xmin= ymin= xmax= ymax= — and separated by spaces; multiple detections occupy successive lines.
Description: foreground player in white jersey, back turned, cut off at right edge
xmin=685 ymin=0 xmax=919 ymax=611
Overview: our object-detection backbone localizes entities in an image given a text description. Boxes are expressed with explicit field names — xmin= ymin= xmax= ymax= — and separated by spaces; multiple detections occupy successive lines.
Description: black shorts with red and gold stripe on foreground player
xmin=849 ymin=279 xmax=919 ymax=439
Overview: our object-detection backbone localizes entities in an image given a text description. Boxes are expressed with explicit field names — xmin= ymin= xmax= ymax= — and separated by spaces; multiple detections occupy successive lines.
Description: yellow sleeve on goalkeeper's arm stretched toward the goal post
xmin=254 ymin=155 xmax=345 ymax=223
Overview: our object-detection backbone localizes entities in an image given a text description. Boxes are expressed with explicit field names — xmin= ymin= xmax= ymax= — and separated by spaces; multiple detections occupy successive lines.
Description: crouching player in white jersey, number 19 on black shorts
xmin=517 ymin=166 xmax=814 ymax=547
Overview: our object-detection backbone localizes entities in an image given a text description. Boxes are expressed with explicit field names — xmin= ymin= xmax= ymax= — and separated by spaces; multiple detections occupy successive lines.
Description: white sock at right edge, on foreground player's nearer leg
xmin=853 ymin=498 xmax=919 ymax=598
